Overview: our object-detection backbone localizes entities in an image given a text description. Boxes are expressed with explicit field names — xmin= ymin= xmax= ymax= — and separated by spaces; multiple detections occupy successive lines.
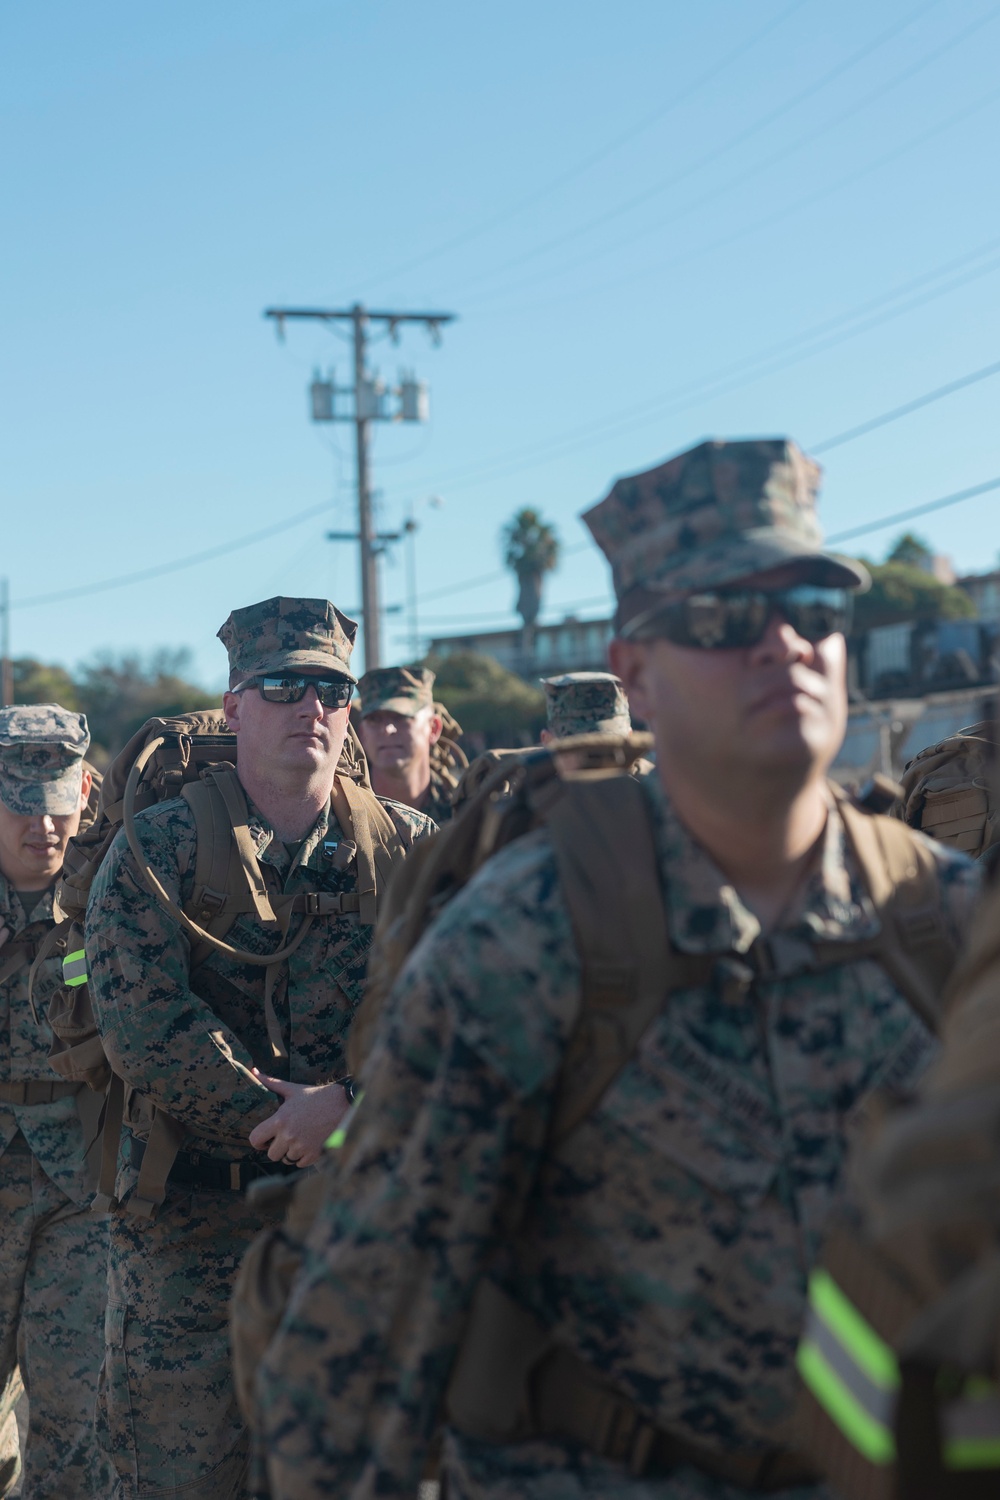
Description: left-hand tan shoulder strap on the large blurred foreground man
xmin=546 ymin=776 xmax=715 ymax=1142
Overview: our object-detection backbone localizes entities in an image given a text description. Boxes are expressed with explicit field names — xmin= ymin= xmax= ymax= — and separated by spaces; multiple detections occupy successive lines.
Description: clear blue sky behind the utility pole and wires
xmin=0 ymin=0 xmax=1000 ymax=686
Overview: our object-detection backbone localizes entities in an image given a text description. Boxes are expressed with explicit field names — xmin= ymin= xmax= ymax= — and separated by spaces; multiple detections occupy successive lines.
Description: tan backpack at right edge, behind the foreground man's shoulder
xmin=901 ymin=719 xmax=1000 ymax=860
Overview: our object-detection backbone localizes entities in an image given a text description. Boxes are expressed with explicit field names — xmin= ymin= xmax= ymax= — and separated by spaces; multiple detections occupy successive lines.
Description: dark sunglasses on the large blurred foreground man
xmin=625 ymin=584 xmax=853 ymax=651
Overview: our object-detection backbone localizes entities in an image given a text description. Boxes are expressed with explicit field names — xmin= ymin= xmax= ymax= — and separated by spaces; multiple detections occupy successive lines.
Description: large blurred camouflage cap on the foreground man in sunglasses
xmin=583 ymin=438 xmax=870 ymax=633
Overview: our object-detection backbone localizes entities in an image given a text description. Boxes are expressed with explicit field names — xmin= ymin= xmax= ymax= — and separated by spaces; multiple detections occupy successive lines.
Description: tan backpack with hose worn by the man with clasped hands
xmin=43 ymin=711 xmax=402 ymax=1217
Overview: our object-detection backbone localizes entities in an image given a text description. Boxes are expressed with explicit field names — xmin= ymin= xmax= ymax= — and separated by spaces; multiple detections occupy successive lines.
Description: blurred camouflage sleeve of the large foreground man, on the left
xmin=258 ymin=836 xmax=579 ymax=1500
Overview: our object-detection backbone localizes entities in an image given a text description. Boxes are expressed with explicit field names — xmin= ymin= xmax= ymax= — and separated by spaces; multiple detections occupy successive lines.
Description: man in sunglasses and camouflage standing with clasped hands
xmin=85 ymin=599 xmax=435 ymax=1500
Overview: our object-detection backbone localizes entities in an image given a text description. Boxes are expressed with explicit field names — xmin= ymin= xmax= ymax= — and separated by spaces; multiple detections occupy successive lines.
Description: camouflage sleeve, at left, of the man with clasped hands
xmin=85 ymin=807 xmax=279 ymax=1145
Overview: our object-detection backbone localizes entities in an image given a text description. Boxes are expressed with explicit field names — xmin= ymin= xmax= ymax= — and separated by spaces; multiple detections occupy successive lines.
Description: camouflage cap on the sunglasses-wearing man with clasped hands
xmin=219 ymin=599 xmax=358 ymax=683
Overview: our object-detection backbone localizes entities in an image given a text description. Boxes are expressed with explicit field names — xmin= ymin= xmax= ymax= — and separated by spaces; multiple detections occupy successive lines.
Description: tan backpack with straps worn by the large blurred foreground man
xmin=232 ymin=750 xmax=955 ymax=1484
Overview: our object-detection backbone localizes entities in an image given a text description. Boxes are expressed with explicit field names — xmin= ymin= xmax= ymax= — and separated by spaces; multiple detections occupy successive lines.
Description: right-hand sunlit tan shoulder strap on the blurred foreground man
xmin=822 ymin=791 xmax=957 ymax=1031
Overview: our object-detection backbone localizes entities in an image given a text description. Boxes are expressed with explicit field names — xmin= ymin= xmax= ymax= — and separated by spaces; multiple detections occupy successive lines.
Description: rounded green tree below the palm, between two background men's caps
xmin=424 ymin=651 xmax=546 ymax=749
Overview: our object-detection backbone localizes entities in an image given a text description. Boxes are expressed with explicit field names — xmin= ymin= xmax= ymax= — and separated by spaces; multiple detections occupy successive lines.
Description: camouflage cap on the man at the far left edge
xmin=0 ymin=704 xmax=90 ymax=818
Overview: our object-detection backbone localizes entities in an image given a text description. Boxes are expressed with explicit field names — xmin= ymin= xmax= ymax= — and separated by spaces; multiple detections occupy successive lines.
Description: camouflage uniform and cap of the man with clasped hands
xmin=87 ymin=600 xmax=433 ymax=1500
